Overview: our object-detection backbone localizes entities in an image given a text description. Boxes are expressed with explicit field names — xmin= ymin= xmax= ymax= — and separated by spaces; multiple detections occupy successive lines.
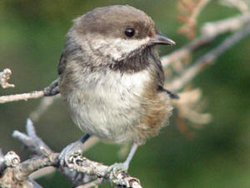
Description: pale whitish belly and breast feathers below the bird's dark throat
xmin=66 ymin=72 xmax=149 ymax=143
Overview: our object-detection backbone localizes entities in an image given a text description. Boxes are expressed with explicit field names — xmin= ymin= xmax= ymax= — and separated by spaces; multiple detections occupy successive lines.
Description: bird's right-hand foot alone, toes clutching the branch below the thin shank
xmin=107 ymin=162 xmax=129 ymax=179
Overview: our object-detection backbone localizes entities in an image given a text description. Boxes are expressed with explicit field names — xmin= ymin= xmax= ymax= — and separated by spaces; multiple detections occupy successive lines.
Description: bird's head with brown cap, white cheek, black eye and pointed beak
xmin=70 ymin=5 xmax=175 ymax=61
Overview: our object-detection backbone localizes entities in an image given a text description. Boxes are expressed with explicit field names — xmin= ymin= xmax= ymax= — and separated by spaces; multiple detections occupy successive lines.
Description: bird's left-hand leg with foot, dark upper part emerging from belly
xmin=59 ymin=134 xmax=90 ymax=165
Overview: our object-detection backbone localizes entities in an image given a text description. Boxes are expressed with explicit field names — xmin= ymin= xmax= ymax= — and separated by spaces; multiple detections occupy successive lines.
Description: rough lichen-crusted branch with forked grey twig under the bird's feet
xmin=4 ymin=120 xmax=141 ymax=188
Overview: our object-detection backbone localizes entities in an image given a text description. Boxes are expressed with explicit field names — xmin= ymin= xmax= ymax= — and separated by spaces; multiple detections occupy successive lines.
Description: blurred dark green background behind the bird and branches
xmin=0 ymin=0 xmax=250 ymax=188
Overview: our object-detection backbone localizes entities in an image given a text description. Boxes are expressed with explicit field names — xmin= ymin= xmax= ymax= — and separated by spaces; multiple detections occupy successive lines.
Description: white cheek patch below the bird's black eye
xmin=91 ymin=37 xmax=150 ymax=60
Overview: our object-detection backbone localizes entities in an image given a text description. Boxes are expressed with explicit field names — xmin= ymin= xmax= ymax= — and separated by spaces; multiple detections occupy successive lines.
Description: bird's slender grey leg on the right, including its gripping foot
xmin=108 ymin=143 xmax=138 ymax=179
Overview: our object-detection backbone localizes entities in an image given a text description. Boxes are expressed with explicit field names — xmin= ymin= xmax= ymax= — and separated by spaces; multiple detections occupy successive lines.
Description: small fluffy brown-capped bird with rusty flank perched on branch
xmin=58 ymin=5 xmax=175 ymax=170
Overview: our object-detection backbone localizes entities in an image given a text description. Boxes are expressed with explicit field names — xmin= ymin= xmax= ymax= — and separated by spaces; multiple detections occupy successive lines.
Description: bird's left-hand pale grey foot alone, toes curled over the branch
xmin=58 ymin=140 xmax=83 ymax=166
